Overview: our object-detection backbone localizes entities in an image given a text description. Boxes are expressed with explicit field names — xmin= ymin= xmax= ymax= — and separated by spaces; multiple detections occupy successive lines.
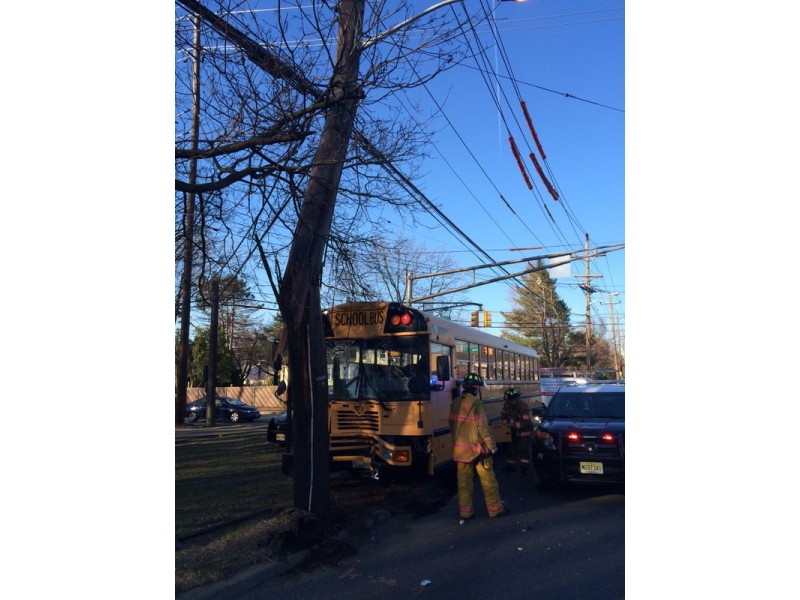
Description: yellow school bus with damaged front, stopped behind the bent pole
xmin=323 ymin=302 xmax=541 ymax=479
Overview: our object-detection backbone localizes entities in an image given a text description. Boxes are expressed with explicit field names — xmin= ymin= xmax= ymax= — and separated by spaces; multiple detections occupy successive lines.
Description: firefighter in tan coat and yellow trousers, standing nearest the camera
xmin=450 ymin=373 xmax=507 ymax=519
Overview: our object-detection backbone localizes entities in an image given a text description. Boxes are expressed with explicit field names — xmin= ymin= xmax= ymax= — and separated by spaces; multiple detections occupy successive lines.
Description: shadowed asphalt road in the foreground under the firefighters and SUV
xmin=231 ymin=464 xmax=625 ymax=600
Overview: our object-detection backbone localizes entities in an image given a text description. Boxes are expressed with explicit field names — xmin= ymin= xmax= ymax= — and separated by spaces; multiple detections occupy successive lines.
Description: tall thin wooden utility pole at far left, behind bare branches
xmin=175 ymin=13 xmax=201 ymax=425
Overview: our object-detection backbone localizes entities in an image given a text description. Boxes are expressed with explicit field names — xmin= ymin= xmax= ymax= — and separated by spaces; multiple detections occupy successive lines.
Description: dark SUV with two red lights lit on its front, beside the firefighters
xmin=532 ymin=384 xmax=625 ymax=488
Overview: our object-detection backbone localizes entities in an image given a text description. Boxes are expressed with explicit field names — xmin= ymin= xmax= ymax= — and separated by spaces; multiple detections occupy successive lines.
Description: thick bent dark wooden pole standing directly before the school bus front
xmin=278 ymin=0 xmax=364 ymax=519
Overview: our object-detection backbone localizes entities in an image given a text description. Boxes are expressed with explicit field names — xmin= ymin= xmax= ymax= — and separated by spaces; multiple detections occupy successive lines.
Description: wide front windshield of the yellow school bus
xmin=327 ymin=336 xmax=430 ymax=401
